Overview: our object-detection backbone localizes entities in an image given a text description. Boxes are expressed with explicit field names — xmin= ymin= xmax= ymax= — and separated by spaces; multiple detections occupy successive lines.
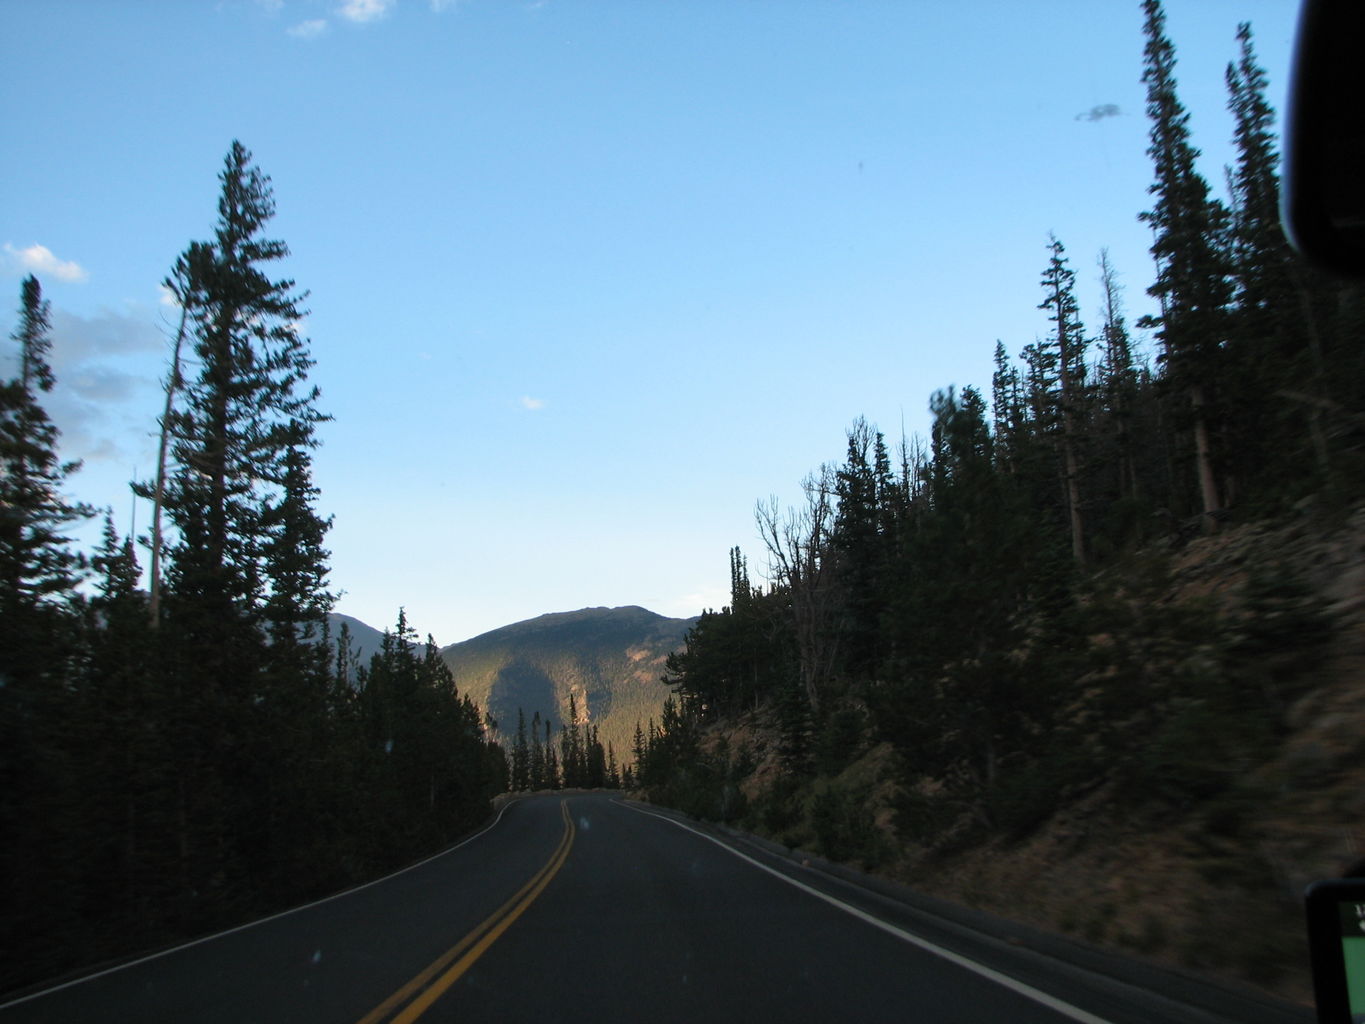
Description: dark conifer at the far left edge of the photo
xmin=0 ymin=276 xmax=90 ymax=983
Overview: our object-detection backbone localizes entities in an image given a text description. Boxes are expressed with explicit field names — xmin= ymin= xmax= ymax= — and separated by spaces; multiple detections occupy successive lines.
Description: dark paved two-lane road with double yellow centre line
xmin=0 ymin=795 xmax=1309 ymax=1024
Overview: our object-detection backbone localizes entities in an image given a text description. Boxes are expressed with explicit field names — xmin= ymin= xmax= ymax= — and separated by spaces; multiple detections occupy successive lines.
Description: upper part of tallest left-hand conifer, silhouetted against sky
xmin=158 ymin=142 xmax=325 ymax=620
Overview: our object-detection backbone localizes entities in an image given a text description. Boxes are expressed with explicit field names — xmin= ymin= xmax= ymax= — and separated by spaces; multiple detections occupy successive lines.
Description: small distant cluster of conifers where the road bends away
xmin=508 ymin=694 xmax=633 ymax=793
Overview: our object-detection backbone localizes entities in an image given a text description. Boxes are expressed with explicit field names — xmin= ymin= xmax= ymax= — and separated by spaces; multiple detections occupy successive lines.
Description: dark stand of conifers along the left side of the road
xmin=0 ymin=143 xmax=506 ymax=990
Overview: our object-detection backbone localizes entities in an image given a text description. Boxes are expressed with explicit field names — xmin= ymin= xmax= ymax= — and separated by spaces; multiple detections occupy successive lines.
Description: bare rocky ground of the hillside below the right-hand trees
xmin=687 ymin=507 xmax=1365 ymax=1001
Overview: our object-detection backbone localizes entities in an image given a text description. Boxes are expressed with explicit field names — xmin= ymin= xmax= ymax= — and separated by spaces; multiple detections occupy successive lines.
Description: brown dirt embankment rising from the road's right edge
xmin=713 ymin=508 xmax=1365 ymax=1002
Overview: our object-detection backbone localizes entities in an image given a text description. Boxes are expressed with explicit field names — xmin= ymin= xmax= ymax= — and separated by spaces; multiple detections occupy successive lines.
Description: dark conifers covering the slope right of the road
xmin=637 ymin=0 xmax=1365 ymax=857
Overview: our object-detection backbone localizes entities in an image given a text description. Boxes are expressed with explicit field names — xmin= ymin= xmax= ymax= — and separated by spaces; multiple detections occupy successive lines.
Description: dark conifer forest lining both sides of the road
xmin=0 ymin=0 xmax=1365 ymax=990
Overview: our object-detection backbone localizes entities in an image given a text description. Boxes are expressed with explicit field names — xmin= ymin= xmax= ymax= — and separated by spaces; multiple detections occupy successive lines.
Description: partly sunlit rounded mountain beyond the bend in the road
xmin=441 ymin=605 xmax=696 ymax=760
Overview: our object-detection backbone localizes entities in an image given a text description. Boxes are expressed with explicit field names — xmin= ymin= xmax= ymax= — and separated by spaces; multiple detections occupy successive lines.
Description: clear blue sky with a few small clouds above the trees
xmin=0 ymin=0 xmax=1297 ymax=643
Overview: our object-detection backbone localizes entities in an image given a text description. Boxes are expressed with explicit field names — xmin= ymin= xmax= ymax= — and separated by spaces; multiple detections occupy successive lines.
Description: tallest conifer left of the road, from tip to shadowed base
xmin=142 ymin=142 xmax=330 ymax=894
